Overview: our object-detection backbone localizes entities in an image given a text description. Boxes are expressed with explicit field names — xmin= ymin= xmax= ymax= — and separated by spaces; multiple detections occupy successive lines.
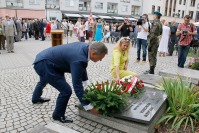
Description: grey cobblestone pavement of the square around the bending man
xmin=0 ymin=35 xmax=177 ymax=133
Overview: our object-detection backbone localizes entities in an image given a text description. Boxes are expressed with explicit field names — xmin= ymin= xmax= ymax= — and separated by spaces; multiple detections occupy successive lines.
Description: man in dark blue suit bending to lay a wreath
xmin=32 ymin=42 xmax=108 ymax=123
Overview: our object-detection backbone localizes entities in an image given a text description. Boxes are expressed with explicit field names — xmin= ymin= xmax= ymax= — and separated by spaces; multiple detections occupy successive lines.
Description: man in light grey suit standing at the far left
xmin=3 ymin=15 xmax=17 ymax=53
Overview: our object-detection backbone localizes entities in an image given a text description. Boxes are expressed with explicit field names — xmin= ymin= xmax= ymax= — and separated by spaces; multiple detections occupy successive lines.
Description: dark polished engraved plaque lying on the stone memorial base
xmin=114 ymin=87 xmax=167 ymax=124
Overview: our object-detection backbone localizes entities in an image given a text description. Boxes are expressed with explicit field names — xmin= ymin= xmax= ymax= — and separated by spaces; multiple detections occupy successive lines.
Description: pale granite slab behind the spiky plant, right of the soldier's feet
xmin=159 ymin=67 xmax=199 ymax=85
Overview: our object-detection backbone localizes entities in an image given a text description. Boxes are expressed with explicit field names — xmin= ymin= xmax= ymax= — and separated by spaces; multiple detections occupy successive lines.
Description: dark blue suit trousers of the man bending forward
xmin=32 ymin=60 xmax=72 ymax=117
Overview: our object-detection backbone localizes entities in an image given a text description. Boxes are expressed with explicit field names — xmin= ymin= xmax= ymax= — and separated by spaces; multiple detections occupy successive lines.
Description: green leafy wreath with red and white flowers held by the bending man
xmin=83 ymin=81 xmax=130 ymax=116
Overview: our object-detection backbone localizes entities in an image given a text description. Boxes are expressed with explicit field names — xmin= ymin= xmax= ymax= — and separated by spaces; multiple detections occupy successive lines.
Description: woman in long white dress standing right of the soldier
xmin=158 ymin=23 xmax=170 ymax=56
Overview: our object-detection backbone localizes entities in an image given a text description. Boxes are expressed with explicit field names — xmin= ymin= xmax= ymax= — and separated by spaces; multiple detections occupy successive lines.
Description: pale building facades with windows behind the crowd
xmin=0 ymin=0 xmax=199 ymax=22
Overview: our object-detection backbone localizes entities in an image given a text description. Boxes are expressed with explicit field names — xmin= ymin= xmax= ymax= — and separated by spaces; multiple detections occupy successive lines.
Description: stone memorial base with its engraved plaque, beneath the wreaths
xmin=79 ymin=86 xmax=167 ymax=133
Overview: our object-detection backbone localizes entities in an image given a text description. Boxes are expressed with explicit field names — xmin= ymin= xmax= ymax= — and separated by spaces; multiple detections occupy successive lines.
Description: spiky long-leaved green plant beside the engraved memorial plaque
xmin=158 ymin=77 xmax=199 ymax=132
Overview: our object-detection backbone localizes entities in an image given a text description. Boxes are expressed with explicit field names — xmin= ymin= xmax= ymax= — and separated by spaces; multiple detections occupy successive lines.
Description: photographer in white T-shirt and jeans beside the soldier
xmin=136 ymin=14 xmax=150 ymax=63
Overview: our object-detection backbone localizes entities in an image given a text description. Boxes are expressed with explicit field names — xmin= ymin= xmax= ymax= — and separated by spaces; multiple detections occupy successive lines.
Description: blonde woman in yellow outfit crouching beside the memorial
xmin=111 ymin=37 xmax=137 ymax=82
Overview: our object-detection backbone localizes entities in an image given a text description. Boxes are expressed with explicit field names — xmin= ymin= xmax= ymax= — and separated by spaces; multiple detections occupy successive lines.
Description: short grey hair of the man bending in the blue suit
xmin=89 ymin=42 xmax=108 ymax=55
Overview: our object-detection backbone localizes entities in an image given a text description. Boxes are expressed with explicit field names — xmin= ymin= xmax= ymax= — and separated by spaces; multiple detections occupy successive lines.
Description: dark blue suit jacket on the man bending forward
xmin=33 ymin=42 xmax=89 ymax=104
